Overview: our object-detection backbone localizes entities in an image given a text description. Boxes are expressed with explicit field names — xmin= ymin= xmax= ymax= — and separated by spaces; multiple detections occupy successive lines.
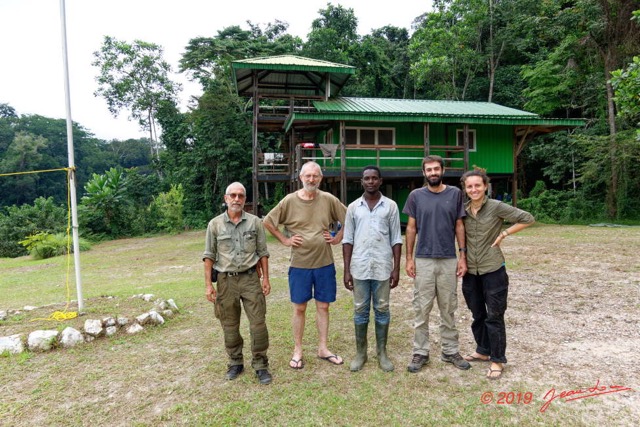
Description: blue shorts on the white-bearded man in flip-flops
xmin=289 ymin=264 xmax=337 ymax=304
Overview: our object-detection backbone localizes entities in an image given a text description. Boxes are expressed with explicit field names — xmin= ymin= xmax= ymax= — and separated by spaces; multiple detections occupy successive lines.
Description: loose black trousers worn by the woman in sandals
xmin=462 ymin=266 xmax=509 ymax=363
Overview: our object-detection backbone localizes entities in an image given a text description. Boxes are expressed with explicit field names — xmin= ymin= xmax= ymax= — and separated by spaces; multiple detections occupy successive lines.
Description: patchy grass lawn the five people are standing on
xmin=0 ymin=225 xmax=640 ymax=426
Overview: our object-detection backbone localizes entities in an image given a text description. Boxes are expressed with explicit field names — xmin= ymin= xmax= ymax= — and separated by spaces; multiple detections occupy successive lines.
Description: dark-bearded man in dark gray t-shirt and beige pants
xmin=402 ymin=156 xmax=471 ymax=373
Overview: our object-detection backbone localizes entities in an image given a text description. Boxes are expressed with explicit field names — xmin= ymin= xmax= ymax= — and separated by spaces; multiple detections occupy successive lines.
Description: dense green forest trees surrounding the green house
xmin=0 ymin=0 xmax=640 ymax=256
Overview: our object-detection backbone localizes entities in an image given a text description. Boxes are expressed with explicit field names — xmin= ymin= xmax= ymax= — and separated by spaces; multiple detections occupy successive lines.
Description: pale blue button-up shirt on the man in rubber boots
xmin=342 ymin=196 xmax=402 ymax=280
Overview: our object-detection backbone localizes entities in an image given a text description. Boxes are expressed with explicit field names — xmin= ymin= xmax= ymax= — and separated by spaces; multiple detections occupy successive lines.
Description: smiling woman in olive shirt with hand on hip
xmin=460 ymin=169 xmax=534 ymax=380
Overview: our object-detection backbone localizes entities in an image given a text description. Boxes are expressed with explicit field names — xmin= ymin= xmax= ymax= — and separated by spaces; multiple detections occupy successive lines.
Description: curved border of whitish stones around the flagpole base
xmin=0 ymin=294 xmax=180 ymax=354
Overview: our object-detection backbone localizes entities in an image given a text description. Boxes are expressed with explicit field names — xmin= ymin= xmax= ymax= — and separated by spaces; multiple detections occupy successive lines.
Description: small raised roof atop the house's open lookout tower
xmin=231 ymin=55 xmax=356 ymax=98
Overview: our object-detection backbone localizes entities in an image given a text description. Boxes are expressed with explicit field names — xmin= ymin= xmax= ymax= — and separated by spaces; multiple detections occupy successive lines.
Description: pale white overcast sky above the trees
xmin=0 ymin=0 xmax=431 ymax=140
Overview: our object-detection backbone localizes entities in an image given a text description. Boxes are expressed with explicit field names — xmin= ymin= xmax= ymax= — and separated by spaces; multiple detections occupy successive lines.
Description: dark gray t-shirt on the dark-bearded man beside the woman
xmin=402 ymin=185 xmax=466 ymax=258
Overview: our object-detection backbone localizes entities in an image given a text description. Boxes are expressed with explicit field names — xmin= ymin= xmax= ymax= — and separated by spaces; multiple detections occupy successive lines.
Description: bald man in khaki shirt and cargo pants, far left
xmin=203 ymin=182 xmax=272 ymax=384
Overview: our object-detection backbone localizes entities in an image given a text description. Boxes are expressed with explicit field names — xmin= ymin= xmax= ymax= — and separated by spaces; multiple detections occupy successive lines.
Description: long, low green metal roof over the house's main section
xmin=285 ymin=97 xmax=584 ymax=130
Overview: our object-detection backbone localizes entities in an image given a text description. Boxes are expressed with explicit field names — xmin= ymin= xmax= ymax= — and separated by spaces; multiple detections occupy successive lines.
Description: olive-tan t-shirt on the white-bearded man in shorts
xmin=264 ymin=190 xmax=347 ymax=268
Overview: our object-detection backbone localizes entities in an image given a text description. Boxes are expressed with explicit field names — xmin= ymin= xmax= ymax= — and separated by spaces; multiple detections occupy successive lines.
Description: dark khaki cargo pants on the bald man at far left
xmin=215 ymin=271 xmax=269 ymax=370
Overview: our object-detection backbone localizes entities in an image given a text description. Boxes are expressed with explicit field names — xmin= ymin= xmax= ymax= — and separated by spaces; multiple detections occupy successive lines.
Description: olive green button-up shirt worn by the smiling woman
xmin=464 ymin=197 xmax=535 ymax=274
